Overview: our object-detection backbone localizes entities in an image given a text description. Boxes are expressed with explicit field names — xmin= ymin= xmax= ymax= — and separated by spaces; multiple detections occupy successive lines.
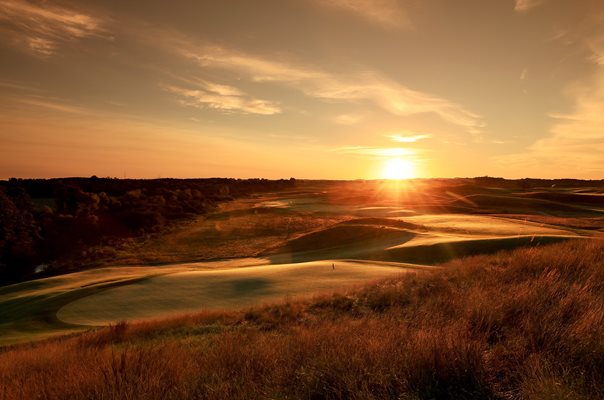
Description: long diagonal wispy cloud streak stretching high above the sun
xmin=172 ymin=41 xmax=485 ymax=136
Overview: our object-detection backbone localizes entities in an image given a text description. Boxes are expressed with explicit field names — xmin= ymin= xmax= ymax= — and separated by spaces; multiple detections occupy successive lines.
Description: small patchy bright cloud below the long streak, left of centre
xmin=162 ymin=81 xmax=281 ymax=115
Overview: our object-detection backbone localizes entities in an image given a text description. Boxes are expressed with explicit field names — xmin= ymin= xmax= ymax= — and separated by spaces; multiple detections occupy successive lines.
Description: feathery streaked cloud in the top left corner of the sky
xmin=0 ymin=0 xmax=106 ymax=57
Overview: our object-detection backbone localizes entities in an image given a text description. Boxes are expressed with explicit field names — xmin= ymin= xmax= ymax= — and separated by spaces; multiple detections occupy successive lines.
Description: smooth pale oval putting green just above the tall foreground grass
xmin=57 ymin=260 xmax=430 ymax=325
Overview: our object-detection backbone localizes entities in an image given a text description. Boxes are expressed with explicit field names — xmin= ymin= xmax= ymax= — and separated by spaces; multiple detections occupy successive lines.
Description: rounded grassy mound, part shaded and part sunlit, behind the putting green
xmin=265 ymin=214 xmax=579 ymax=264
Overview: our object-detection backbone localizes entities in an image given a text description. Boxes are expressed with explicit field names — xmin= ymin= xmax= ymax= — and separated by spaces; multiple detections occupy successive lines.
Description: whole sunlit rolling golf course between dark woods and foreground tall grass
xmin=0 ymin=182 xmax=604 ymax=344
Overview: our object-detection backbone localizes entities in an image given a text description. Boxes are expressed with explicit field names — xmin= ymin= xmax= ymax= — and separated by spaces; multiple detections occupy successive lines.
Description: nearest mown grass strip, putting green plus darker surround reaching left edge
xmin=0 ymin=259 xmax=430 ymax=345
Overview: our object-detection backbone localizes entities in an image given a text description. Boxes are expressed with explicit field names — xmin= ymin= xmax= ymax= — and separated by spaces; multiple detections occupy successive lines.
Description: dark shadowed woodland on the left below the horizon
xmin=0 ymin=176 xmax=295 ymax=285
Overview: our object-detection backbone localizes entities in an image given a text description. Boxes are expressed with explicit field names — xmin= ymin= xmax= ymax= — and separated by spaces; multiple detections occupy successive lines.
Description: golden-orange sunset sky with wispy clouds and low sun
xmin=0 ymin=0 xmax=604 ymax=179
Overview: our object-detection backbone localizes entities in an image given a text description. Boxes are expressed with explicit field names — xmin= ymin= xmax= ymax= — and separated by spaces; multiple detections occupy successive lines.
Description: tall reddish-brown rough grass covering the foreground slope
xmin=0 ymin=240 xmax=604 ymax=399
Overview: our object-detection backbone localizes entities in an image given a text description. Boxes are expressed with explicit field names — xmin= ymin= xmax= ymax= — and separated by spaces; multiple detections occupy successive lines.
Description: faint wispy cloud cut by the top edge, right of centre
xmin=313 ymin=0 xmax=411 ymax=29
